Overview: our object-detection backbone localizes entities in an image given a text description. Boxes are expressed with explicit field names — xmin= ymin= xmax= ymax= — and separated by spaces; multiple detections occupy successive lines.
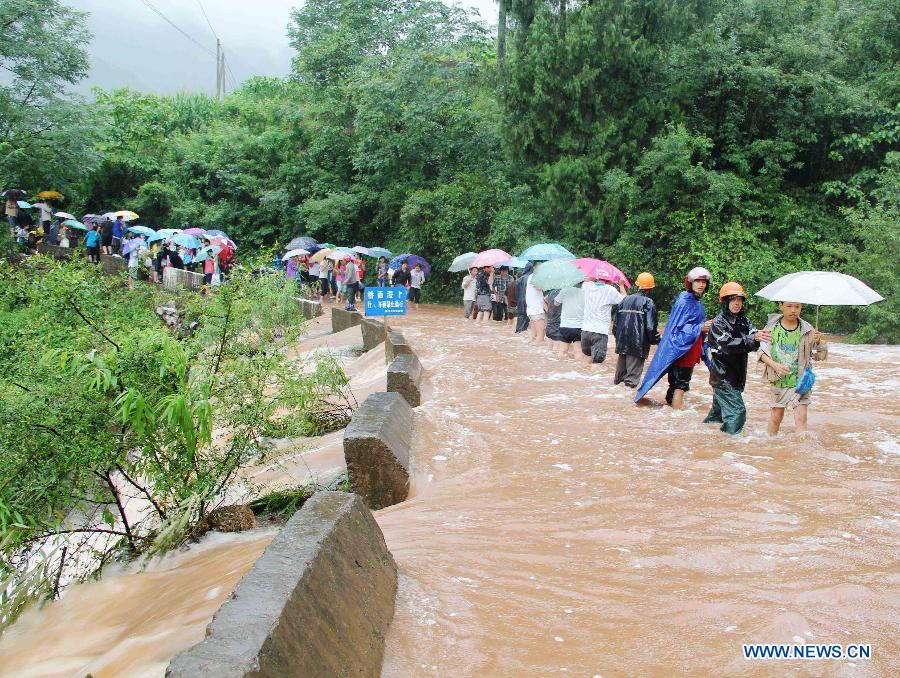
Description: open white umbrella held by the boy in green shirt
xmin=754 ymin=271 xmax=884 ymax=327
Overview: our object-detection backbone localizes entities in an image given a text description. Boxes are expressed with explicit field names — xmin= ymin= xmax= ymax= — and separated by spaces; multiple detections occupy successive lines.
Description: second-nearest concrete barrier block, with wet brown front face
xmin=344 ymin=392 xmax=413 ymax=510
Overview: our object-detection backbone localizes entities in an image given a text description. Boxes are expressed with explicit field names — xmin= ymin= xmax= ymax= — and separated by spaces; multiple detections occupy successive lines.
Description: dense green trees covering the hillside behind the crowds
xmin=0 ymin=0 xmax=900 ymax=342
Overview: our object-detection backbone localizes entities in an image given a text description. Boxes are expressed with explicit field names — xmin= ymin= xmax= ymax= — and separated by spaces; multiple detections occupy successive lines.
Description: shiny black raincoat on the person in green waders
xmin=706 ymin=299 xmax=759 ymax=391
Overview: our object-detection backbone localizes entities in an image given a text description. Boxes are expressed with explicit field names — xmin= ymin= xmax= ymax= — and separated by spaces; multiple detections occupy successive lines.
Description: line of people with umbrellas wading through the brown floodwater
xmin=449 ymin=243 xmax=883 ymax=435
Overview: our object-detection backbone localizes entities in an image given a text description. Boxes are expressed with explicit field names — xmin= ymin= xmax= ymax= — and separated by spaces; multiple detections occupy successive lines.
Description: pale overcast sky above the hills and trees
xmin=63 ymin=0 xmax=497 ymax=94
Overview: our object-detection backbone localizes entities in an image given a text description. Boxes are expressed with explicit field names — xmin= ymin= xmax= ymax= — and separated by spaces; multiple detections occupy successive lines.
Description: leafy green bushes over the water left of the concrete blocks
xmin=0 ymin=256 xmax=355 ymax=626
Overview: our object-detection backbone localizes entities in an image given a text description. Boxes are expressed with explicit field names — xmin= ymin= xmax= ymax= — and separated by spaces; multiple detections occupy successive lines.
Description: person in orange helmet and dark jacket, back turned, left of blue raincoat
xmin=613 ymin=273 xmax=659 ymax=388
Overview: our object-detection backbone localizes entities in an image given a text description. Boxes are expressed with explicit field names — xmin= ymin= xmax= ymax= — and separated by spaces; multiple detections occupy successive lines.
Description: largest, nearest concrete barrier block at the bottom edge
xmin=166 ymin=492 xmax=397 ymax=678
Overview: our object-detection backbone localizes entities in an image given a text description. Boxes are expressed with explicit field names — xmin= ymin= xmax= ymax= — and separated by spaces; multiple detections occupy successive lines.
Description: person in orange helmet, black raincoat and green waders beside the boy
xmin=703 ymin=282 xmax=772 ymax=434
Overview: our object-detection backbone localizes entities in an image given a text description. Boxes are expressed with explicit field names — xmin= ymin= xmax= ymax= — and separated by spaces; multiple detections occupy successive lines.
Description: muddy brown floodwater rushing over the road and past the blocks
xmin=0 ymin=307 xmax=900 ymax=678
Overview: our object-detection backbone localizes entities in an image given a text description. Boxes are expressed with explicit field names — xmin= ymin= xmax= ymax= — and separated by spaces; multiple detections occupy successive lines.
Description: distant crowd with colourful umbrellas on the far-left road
xmin=0 ymin=189 xmax=237 ymax=286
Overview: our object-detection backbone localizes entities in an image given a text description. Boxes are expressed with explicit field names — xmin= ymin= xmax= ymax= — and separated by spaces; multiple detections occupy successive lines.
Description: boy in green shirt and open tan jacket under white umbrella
xmin=759 ymin=301 xmax=822 ymax=436
